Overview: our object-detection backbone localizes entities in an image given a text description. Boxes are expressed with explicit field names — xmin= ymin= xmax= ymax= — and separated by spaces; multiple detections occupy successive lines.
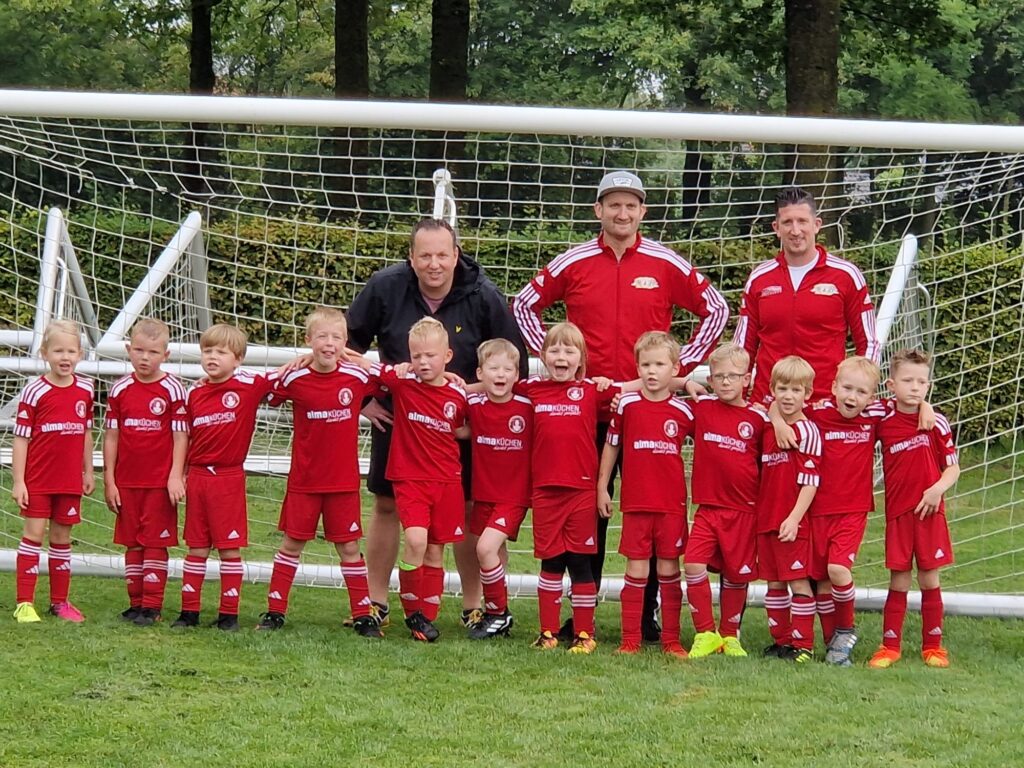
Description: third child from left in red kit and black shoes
xmin=171 ymin=324 xmax=276 ymax=632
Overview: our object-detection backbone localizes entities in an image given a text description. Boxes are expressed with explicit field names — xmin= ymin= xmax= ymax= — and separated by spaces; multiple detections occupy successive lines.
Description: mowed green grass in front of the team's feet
xmin=0 ymin=574 xmax=1024 ymax=768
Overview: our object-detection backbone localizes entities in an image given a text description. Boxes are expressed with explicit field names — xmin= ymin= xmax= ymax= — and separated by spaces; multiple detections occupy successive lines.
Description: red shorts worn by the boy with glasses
xmin=684 ymin=507 xmax=758 ymax=584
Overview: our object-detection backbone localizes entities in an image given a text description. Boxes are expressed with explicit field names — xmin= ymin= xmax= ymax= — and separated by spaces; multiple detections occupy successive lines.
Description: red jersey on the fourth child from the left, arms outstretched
xmin=270 ymin=362 xmax=379 ymax=494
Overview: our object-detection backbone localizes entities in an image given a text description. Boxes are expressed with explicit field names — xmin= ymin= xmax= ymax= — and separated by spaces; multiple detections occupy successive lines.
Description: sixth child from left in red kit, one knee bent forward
xmin=467 ymin=339 xmax=534 ymax=640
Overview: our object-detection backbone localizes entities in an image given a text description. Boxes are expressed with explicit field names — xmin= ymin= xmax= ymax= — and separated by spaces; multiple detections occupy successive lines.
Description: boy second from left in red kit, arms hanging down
xmin=103 ymin=317 xmax=188 ymax=627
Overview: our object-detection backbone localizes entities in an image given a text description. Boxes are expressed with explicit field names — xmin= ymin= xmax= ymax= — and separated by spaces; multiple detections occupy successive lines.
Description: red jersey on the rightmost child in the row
xmin=879 ymin=410 xmax=959 ymax=520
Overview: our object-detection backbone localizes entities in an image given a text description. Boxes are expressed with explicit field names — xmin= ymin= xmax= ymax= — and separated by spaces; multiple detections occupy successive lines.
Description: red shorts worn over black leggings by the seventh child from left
xmin=534 ymin=487 xmax=597 ymax=560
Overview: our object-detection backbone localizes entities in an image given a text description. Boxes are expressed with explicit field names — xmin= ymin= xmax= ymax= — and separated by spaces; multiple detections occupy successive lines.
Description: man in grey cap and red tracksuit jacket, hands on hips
xmin=512 ymin=171 xmax=729 ymax=641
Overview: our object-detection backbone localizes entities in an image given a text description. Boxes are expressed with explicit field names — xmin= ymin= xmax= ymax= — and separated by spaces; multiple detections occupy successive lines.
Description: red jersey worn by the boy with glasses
xmin=689 ymin=397 xmax=771 ymax=512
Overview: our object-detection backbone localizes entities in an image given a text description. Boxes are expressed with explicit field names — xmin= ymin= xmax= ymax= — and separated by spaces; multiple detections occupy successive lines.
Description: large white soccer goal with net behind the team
xmin=0 ymin=91 xmax=1024 ymax=614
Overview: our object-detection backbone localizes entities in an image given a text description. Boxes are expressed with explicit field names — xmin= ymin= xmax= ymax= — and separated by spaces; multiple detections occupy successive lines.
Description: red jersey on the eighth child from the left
xmin=607 ymin=392 xmax=693 ymax=516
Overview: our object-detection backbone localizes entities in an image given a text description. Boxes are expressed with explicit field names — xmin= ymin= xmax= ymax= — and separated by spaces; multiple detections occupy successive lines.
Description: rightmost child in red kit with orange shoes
xmin=868 ymin=350 xmax=959 ymax=669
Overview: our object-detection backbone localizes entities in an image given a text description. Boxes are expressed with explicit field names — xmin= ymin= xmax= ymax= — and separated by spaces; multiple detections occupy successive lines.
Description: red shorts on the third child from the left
xmin=184 ymin=467 xmax=249 ymax=549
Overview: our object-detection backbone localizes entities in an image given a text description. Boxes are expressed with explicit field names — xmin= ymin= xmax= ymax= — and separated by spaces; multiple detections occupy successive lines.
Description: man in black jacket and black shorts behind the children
xmin=348 ymin=219 xmax=526 ymax=616
